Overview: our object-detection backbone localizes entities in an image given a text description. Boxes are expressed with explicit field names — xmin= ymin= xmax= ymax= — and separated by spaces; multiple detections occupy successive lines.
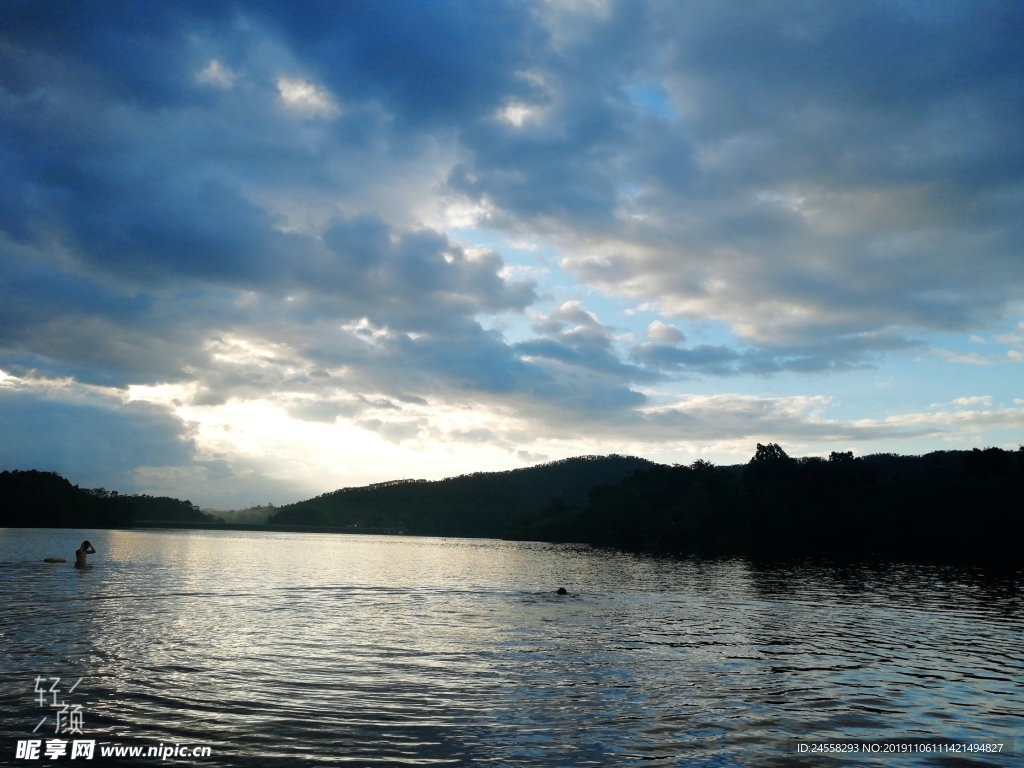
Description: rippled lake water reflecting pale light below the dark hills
xmin=0 ymin=528 xmax=1024 ymax=766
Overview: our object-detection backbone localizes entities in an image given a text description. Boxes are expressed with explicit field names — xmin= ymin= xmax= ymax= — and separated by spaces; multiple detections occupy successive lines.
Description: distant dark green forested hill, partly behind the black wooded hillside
xmin=268 ymin=456 xmax=656 ymax=537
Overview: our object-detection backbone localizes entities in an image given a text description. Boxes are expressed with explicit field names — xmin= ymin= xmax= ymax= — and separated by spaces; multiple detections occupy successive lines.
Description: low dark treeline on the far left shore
xmin=0 ymin=469 xmax=216 ymax=528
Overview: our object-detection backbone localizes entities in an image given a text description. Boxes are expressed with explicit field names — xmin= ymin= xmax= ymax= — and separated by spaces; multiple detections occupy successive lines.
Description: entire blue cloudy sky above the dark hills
xmin=0 ymin=0 xmax=1024 ymax=509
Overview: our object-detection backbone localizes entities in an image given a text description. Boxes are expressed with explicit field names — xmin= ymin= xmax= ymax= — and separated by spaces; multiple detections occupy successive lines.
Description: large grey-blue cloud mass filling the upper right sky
xmin=449 ymin=3 xmax=1024 ymax=355
